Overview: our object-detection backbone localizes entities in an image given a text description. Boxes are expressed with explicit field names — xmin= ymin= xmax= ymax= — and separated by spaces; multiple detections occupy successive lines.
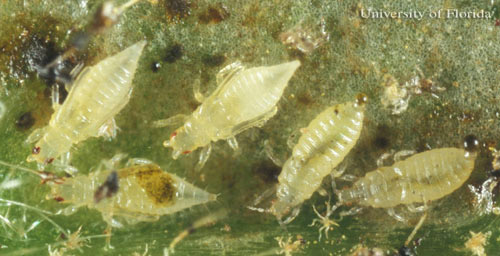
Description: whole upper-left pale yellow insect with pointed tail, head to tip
xmin=27 ymin=41 xmax=146 ymax=164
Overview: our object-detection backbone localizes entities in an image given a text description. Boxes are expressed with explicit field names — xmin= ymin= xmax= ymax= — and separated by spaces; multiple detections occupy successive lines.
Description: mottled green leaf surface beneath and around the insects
xmin=0 ymin=0 xmax=500 ymax=255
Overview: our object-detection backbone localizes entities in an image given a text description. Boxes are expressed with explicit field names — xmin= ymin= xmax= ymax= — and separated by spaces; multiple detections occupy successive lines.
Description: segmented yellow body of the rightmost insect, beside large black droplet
xmin=339 ymin=148 xmax=476 ymax=208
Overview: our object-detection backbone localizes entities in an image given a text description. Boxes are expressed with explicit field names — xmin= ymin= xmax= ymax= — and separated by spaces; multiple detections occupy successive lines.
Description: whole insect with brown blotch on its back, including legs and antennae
xmin=0 ymin=158 xmax=217 ymax=246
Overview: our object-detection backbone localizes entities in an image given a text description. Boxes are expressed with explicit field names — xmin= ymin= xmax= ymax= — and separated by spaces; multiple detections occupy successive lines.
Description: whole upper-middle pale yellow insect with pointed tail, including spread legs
xmin=155 ymin=61 xmax=300 ymax=170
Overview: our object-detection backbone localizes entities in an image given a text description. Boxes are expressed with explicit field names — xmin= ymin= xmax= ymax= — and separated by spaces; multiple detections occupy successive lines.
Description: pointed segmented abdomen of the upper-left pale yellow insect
xmin=50 ymin=41 xmax=146 ymax=143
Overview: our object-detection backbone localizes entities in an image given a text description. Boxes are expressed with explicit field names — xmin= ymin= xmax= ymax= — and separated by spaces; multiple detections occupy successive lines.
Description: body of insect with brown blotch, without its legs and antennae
xmin=51 ymin=164 xmax=216 ymax=215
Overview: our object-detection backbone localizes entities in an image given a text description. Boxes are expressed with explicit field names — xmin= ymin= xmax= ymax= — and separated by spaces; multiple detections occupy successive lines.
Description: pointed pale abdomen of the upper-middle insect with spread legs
xmin=195 ymin=61 xmax=300 ymax=138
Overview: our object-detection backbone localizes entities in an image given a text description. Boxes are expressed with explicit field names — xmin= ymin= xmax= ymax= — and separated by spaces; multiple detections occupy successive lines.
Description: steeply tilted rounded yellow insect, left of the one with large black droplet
xmin=269 ymin=94 xmax=367 ymax=223
